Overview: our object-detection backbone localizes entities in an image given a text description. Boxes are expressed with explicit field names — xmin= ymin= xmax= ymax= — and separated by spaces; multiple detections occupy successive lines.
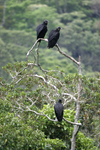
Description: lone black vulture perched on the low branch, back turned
xmin=54 ymin=99 xmax=64 ymax=121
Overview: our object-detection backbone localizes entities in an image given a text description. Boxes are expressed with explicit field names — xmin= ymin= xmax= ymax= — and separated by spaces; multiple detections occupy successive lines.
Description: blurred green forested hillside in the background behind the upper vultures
xmin=0 ymin=0 xmax=100 ymax=79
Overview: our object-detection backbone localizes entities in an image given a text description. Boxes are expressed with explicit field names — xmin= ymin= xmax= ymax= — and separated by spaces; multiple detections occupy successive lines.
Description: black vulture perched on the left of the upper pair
xmin=36 ymin=20 xmax=48 ymax=42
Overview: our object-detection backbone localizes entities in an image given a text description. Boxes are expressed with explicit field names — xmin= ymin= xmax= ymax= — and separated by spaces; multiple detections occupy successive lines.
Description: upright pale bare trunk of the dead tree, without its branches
xmin=71 ymin=56 xmax=81 ymax=150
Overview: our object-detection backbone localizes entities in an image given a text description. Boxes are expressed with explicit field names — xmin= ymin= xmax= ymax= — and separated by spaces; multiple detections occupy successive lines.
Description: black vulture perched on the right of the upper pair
xmin=48 ymin=27 xmax=61 ymax=48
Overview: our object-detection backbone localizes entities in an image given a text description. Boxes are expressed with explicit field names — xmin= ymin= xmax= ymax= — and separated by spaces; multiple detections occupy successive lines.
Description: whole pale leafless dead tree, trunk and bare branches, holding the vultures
xmin=9 ymin=38 xmax=81 ymax=150
